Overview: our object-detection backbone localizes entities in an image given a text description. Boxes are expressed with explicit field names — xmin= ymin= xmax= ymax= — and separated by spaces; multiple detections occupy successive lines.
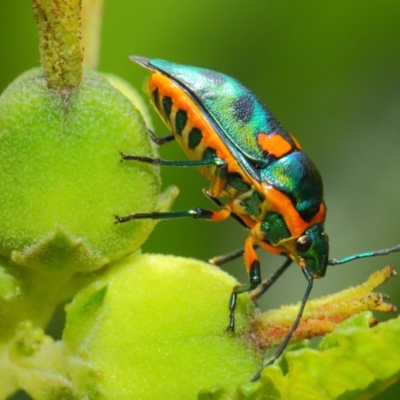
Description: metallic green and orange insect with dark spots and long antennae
xmin=116 ymin=56 xmax=400 ymax=381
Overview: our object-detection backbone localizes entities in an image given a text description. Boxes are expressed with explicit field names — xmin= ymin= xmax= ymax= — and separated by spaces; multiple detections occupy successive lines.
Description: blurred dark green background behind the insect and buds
xmin=0 ymin=0 xmax=400 ymax=399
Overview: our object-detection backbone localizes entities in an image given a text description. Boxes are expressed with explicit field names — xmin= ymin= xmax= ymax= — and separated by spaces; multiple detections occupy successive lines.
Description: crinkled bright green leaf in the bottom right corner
xmin=199 ymin=312 xmax=400 ymax=400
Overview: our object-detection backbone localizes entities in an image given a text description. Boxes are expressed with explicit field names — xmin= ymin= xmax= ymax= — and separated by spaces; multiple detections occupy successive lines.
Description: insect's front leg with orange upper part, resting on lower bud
xmin=227 ymin=236 xmax=261 ymax=332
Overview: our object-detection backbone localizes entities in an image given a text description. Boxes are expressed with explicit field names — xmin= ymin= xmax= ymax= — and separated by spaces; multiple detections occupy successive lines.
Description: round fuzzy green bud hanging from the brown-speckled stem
xmin=0 ymin=69 xmax=160 ymax=271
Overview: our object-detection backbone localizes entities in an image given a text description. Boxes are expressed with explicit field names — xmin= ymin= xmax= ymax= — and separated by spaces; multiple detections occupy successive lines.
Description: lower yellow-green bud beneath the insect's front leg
xmin=63 ymin=255 xmax=261 ymax=400
